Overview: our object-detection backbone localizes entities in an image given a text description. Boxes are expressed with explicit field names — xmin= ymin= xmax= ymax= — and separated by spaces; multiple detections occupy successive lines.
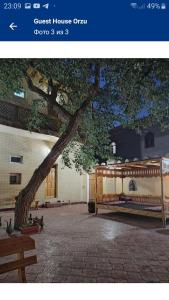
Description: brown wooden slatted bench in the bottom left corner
xmin=0 ymin=235 xmax=37 ymax=282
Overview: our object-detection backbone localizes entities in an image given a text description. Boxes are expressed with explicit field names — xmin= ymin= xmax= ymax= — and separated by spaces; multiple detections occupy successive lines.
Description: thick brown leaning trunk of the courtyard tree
xmin=14 ymin=111 xmax=81 ymax=230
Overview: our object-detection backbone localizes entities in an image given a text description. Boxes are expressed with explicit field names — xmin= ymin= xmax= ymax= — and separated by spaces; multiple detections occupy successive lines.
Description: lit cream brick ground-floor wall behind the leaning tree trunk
xmin=0 ymin=125 xmax=87 ymax=209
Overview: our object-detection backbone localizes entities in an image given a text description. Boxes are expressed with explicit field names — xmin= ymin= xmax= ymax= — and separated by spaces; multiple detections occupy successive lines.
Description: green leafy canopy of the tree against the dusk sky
xmin=0 ymin=59 xmax=169 ymax=171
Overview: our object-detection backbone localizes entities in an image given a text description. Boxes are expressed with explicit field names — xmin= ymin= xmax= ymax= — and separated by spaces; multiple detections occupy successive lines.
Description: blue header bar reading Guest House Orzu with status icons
xmin=0 ymin=0 xmax=169 ymax=41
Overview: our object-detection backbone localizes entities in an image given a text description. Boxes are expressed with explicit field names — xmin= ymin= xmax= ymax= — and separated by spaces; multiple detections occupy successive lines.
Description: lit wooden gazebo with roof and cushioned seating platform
xmin=94 ymin=158 xmax=169 ymax=227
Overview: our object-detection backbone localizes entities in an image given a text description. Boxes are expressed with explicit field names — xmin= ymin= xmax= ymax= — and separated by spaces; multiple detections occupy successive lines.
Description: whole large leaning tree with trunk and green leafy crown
xmin=0 ymin=59 xmax=169 ymax=229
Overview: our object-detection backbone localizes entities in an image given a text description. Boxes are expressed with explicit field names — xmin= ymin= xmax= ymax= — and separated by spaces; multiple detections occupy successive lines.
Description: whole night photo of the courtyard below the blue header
xmin=0 ymin=59 xmax=169 ymax=283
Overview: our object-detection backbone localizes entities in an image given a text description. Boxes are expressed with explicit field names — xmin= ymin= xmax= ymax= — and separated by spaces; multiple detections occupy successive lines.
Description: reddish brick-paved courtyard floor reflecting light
xmin=0 ymin=204 xmax=169 ymax=283
